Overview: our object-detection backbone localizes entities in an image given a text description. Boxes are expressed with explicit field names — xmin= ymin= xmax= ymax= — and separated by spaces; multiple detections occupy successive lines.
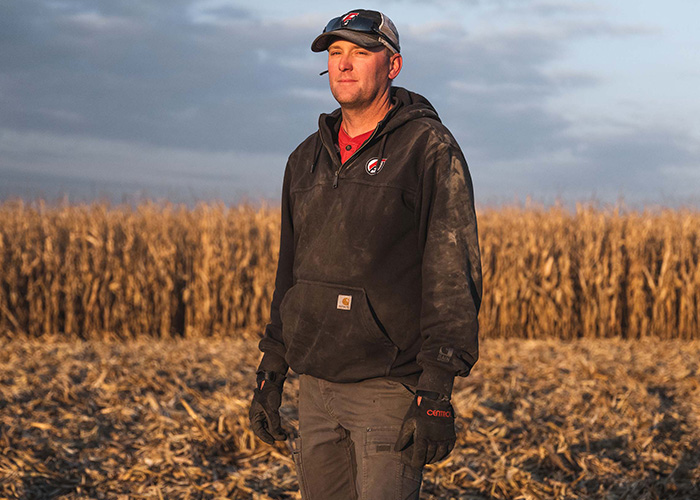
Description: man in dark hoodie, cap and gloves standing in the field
xmin=250 ymin=9 xmax=481 ymax=500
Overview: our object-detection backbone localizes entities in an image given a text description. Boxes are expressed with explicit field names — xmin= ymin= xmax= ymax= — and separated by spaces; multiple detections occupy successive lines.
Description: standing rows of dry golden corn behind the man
xmin=0 ymin=202 xmax=700 ymax=339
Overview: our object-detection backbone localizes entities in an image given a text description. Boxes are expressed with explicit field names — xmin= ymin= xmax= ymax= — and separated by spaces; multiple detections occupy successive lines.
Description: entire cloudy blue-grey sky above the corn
xmin=0 ymin=0 xmax=700 ymax=207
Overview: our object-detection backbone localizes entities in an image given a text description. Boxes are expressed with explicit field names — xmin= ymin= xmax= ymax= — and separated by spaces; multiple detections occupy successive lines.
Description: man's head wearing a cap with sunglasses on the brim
xmin=311 ymin=9 xmax=403 ymax=110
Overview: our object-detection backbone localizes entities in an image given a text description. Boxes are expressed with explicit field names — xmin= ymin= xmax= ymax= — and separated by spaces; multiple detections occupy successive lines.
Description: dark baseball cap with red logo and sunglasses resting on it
xmin=311 ymin=9 xmax=401 ymax=54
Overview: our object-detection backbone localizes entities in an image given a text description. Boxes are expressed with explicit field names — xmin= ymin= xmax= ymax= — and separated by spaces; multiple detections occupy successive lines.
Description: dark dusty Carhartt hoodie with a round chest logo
xmin=259 ymin=87 xmax=482 ymax=396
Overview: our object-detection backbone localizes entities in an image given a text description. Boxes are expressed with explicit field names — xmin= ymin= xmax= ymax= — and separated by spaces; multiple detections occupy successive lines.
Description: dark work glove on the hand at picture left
xmin=248 ymin=371 xmax=287 ymax=444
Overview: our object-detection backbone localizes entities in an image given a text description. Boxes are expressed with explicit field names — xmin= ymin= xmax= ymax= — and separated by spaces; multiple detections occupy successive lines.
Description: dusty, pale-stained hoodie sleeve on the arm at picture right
xmin=416 ymin=138 xmax=482 ymax=395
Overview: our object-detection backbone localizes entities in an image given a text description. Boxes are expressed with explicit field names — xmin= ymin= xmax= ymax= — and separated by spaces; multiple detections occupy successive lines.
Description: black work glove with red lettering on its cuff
xmin=394 ymin=391 xmax=457 ymax=469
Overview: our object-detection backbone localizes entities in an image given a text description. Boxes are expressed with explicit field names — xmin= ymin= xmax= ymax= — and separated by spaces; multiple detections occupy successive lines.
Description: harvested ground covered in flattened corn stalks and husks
xmin=0 ymin=333 xmax=700 ymax=500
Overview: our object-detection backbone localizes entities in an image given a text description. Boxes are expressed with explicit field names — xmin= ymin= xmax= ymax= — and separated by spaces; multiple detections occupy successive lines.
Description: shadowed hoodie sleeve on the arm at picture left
xmin=258 ymin=158 xmax=294 ymax=374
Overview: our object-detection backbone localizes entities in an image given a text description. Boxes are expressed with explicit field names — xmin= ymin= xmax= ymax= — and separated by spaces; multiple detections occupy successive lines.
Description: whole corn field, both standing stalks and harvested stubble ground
xmin=0 ymin=202 xmax=700 ymax=500
